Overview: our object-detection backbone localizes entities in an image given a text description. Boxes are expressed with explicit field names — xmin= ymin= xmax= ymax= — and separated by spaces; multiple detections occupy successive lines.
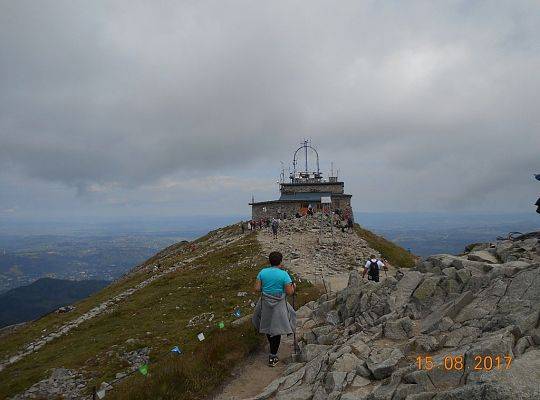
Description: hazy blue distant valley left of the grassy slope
xmin=0 ymin=232 xmax=204 ymax=293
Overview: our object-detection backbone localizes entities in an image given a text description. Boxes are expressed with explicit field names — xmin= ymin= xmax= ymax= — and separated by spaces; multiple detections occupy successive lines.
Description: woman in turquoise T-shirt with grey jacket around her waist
xmin=251 ymin=251 xmax=296 ymax=367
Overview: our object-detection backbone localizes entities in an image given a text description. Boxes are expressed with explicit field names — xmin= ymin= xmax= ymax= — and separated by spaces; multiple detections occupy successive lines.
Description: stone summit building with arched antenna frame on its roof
xmin=249 ymin=140 xmax=352 ymax=220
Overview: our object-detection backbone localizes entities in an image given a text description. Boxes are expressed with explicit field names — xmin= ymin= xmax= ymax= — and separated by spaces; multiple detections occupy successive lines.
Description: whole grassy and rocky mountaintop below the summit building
xmin=0 ymin=219 xmax=540 ymax=400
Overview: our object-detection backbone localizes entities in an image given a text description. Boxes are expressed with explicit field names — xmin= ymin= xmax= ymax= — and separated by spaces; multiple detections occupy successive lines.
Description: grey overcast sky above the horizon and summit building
xmin=0 ymin=0 xmax=540 ymax=219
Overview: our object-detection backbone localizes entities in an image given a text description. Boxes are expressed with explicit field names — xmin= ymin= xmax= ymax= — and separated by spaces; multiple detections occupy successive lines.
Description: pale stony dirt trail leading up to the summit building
xmin=213 ymin=217 xmax=395 ymax=400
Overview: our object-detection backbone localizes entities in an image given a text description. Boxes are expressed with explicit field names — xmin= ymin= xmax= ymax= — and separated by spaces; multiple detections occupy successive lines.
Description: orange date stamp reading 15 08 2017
xmin=416 ymin=354 xmax=512 ymax=371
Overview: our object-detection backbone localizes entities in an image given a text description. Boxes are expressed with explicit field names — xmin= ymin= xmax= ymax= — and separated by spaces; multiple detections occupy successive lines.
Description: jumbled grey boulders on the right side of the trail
xmin=249 ymin=227 xmax=540 ymax=400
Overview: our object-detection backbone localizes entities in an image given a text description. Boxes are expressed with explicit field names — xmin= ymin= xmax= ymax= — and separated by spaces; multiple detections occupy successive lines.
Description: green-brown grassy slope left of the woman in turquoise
xmin=0 ymin=227 xmax=317 ymax=399
